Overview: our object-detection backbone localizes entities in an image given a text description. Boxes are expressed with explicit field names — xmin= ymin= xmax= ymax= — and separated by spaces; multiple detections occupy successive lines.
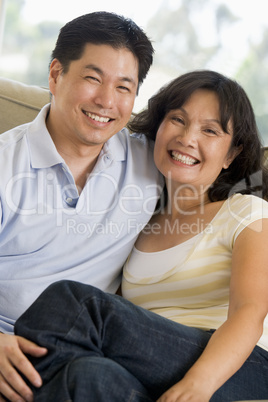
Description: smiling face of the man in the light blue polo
xmin=47 ymin=44 xmax=139 ymax=151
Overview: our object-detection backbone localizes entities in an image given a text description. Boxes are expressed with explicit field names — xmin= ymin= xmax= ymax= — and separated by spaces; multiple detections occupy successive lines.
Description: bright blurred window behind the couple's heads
xmin=0 ymin=0 xmax=268 ymax=145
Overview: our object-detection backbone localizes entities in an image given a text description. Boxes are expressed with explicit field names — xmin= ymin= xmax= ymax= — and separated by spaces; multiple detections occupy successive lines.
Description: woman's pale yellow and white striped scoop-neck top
xmin=122 ymin=194 xmax=268 ymax=350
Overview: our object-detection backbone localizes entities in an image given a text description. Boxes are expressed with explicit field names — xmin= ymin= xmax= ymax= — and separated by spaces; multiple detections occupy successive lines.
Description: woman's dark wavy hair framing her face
xmin=128 ymin=70 xmax=268 ymax=201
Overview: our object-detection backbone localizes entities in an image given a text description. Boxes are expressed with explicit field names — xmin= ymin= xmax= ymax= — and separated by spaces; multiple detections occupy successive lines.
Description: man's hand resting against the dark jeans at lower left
xmin=0 ymin=333 xmax=47 ymax=402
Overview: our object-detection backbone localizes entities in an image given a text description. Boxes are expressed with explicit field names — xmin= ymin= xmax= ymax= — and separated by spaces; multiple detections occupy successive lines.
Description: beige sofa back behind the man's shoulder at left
xmin=0 ymin=77 xmax=50 ymax=134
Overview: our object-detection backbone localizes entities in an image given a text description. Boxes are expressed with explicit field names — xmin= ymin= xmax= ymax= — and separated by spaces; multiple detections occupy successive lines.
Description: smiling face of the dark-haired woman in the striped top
xmin=154 ymin=89 xmax=238 ymax=193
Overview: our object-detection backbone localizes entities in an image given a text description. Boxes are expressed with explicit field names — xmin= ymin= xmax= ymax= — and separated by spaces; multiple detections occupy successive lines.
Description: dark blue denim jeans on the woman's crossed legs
xmin=15 ymin=281 xmax=268 ymax=402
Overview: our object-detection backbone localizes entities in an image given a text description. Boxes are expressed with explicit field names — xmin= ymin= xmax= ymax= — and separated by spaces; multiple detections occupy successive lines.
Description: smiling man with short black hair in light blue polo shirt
xmin=0 ymin=12 xmax=160 ymax=401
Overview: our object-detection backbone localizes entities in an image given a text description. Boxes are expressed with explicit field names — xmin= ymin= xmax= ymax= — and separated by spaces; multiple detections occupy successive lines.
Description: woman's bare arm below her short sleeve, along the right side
xmin=158 ymin=219 xmax=268 ymax=402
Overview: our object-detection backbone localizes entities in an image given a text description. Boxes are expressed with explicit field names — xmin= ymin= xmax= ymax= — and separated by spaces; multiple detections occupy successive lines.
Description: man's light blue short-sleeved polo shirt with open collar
xmin=0 ymin=105 xmax=162 ymax=332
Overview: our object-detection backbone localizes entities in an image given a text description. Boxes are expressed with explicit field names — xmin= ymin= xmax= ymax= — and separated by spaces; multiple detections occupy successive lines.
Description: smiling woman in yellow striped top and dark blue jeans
xmin=16 ymin=71 xmax=268 ymax=402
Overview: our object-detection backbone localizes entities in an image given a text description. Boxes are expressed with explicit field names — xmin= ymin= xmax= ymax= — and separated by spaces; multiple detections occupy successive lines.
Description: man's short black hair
xmin=51 ymin=11 xmax=154 ymax=91
